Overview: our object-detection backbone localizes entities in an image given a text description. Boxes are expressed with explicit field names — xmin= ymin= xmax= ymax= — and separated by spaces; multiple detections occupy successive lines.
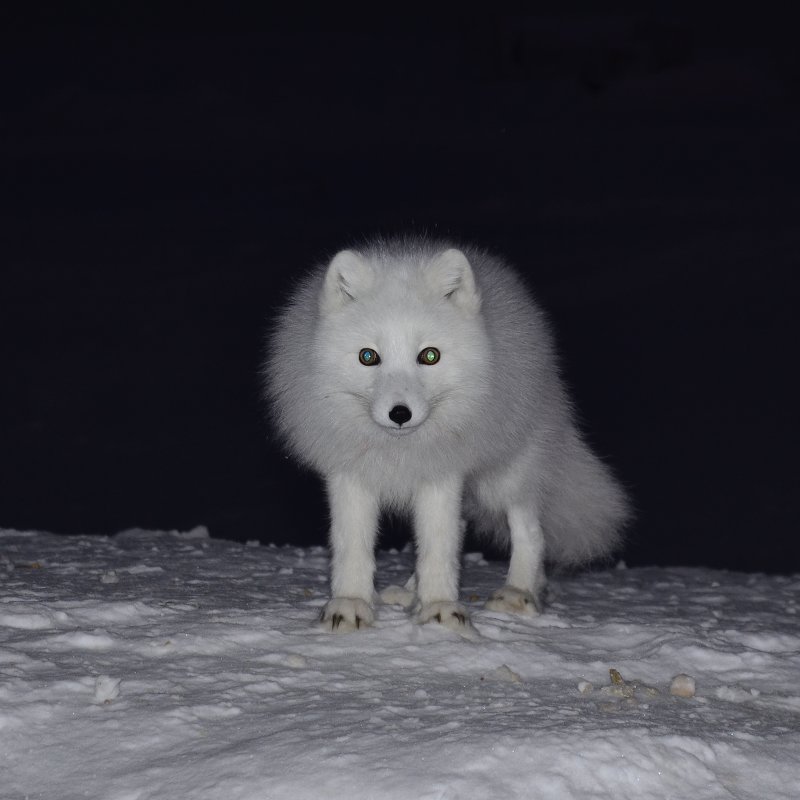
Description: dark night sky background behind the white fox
xmin=0 ymin=3 xmax=800 ymax=571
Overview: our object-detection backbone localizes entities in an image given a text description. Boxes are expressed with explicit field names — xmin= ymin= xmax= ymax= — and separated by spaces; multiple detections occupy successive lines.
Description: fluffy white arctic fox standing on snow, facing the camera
xmin=264 ymin=238 xmax=628 ymax=631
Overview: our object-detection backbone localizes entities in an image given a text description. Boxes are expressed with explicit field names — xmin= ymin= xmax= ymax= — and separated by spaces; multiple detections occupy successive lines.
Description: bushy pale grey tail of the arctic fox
xmin=542 ymin=430 xmax=632 ymax=565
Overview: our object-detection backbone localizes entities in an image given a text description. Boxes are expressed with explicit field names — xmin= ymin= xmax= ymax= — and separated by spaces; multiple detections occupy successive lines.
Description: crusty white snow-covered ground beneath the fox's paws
xmin=0 ymin=529 xmax=800 ymax=800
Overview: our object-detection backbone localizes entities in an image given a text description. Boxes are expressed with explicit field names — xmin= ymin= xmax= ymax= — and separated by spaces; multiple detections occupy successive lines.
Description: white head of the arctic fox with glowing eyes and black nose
xmin=315 ymin=248 xmax=488 ymax=439
